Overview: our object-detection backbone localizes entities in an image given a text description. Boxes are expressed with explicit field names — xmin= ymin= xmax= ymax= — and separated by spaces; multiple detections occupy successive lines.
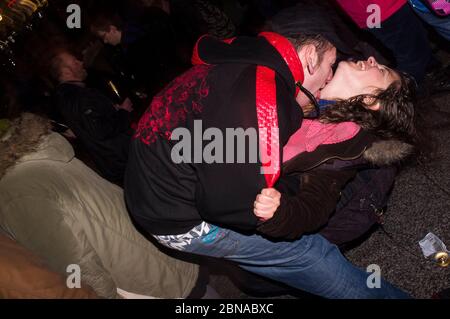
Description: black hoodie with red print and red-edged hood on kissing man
xmin=125 ymin=34 xmax=303 ymax=235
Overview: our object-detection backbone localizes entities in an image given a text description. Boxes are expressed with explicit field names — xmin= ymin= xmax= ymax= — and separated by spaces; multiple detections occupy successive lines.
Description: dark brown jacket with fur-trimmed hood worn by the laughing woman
xmin=258 ymin=130 xmax=412 ymax=239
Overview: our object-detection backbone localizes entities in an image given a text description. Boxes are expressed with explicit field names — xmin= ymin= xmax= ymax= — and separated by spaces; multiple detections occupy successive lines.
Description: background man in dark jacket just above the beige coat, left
xmin=50 ymin=51 xmax=133 ymax=185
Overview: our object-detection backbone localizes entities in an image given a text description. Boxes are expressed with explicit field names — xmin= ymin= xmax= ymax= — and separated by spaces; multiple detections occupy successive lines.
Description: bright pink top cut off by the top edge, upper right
xmin=336 ymin=0 xmax=407 ymax=28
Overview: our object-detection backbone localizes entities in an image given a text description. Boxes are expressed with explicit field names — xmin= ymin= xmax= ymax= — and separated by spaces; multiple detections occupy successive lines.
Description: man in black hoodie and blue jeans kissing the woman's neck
xmin=125 ymin=32 xmax=407 ymax=298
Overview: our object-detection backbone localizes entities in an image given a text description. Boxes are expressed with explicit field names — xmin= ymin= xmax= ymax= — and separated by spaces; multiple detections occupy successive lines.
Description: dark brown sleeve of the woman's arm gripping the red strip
xmin=257 ymin=170 xmax=355 ymax=240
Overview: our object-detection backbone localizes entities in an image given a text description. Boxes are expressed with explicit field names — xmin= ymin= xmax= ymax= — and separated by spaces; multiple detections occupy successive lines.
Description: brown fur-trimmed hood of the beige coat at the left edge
xmin=0 ymin=113 xmax=74 ymax=178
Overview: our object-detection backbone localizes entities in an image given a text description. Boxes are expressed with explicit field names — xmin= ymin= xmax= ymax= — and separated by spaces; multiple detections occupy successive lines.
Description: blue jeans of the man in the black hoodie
xmin=178 ymin=226 xmax=409 ymax=299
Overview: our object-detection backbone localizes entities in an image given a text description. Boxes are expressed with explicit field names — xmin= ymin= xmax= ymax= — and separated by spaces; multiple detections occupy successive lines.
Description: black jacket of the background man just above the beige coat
xmin=55 ymin=83 xmax=131 ymax=184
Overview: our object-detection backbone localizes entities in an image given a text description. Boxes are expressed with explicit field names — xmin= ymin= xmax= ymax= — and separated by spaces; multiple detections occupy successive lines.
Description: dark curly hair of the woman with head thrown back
xmin=319 ymin=73 xmax=417 ymax=144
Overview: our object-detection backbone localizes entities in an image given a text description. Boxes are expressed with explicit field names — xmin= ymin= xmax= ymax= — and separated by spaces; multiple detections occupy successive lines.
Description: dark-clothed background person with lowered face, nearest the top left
xmin=91 ymin=8 xmax=186 ymax=96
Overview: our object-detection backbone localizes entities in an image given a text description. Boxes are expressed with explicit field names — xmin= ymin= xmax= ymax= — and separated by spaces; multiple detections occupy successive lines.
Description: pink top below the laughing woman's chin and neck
xmin=283 ymin=120 xmax=361 ymax=162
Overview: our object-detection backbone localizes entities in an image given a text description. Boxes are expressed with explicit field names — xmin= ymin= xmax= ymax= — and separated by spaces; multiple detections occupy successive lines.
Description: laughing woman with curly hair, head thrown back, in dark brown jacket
xmin=254 ymin=57 xmax=418 ymax=244
